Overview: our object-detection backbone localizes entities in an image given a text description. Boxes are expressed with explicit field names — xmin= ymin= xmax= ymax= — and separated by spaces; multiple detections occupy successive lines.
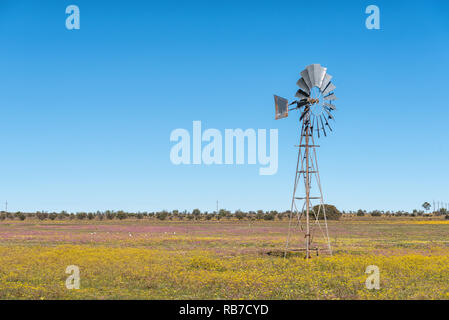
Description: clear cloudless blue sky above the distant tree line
xmin=0 ymin=0 xmax=449 ymax=211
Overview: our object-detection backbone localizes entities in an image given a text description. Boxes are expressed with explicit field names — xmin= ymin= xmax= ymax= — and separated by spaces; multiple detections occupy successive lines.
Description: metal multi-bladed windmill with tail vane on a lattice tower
xmin=274 ymin=64 xmax=337 ymax=259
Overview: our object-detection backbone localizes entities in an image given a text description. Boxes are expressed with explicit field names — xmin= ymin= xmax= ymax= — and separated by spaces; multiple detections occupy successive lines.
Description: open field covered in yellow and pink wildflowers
xmin=0 ymin=217 xmax=449 ymax=299
